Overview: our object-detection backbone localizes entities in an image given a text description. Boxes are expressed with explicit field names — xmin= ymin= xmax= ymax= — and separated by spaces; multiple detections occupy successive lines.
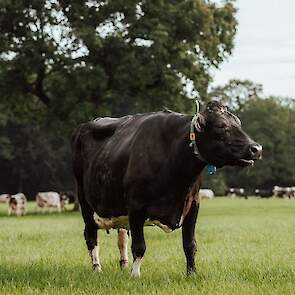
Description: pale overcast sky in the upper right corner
xmin=214 ymin=0 xmax=295 ymax=98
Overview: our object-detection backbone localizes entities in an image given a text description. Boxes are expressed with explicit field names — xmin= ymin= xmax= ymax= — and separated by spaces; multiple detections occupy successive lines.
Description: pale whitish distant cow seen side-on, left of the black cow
xmin=36 ymin=192 xmax=68 ymax=213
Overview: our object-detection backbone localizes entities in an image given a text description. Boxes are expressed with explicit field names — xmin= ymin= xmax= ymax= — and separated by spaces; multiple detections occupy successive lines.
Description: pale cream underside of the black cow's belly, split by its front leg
xmin=93 ymin=213 xmax=173 ymax=233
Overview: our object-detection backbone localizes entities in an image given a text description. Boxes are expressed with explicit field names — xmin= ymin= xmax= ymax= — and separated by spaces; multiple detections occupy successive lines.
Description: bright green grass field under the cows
xmin=0 ymin=198 xmax=295 ymax=295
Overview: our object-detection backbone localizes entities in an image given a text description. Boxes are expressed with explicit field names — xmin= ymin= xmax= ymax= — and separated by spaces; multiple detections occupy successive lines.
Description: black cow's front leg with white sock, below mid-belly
xmin=129 ymin=211 xmax=146 ymax=278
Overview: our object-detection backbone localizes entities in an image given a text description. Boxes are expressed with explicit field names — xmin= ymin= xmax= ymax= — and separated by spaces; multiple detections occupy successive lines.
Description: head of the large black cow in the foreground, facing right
xmin=196 ymin=101 xmax=262 ymax=167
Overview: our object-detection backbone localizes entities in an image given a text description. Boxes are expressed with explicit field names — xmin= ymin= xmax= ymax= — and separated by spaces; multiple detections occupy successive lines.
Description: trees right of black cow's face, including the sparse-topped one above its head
xmin=210 ymin=80 xmax=295 ymax=193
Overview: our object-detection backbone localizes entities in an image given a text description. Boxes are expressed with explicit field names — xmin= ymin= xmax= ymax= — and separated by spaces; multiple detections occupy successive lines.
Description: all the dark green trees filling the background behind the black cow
xmin=0 ymin=0 xmax=295 ymax=197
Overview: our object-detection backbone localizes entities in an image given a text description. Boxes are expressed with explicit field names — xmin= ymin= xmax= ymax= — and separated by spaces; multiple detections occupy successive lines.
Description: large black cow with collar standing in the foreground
xmin=73 ymin=101 xmax=262 ymax=277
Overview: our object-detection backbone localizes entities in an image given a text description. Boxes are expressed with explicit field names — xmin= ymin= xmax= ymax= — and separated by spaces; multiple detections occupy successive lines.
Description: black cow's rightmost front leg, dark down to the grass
xmin=182 ymin=200 xmax=199 ymax=275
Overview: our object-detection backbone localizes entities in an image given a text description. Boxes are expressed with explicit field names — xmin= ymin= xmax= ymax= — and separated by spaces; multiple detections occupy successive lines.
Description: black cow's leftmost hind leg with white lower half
xmin=80 ymin=190 xmax=101 ymax=272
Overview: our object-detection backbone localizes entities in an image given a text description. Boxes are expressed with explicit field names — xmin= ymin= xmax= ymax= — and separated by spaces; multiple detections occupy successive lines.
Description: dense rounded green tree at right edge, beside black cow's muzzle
xmin=227 ymin=97 xmax=295 ymax=188
